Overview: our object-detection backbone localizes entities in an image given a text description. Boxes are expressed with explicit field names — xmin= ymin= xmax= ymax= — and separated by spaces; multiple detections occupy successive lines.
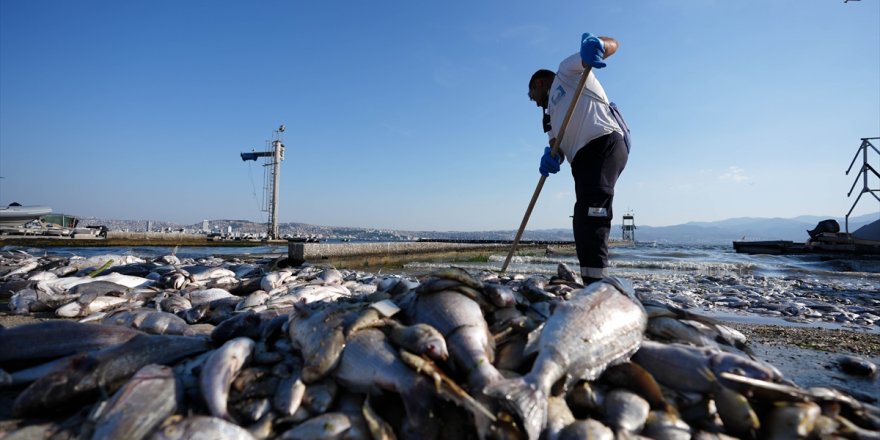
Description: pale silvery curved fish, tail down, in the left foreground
xmin=199 ymin=337 xmax=254 ymax=419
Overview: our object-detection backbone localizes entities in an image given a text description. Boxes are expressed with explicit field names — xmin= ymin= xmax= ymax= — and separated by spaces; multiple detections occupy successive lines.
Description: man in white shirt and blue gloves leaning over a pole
xmin=529 ymin=33 xmax=629 ymax=285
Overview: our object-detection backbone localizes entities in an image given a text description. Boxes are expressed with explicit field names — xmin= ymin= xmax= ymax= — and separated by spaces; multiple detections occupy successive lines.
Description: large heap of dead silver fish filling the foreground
xmin=0 ymin=251 xmax=880 ymax=440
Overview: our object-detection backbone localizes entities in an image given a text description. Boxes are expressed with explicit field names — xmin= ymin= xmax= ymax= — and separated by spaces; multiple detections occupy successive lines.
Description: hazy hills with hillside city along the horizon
xmin=82 ymin=213 xmax=880 ymax=244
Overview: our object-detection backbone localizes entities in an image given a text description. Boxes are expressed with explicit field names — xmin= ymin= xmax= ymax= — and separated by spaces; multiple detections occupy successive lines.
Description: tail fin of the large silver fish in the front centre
xmin=483 ymin=377 xmax=547 ymax=440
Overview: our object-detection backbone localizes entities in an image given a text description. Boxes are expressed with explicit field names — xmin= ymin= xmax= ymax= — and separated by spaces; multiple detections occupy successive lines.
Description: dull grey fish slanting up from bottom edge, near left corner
xmin=92 ymin=365 xmax=177 ymax=440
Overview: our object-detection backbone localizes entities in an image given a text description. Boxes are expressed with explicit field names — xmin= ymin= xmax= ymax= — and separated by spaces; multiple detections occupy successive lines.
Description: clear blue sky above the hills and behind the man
xmin=0 ymin=0 xmax=880 ymax=230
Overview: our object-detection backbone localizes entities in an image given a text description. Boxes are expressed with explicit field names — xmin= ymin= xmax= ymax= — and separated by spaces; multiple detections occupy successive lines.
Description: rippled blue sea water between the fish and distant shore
xmin=17 ymin=242 xmax=880 ymax=282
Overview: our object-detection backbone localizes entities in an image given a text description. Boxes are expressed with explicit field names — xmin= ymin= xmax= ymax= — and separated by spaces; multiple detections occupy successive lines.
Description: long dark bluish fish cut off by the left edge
xmin=0 ymin=320 xmax=143 ymax=365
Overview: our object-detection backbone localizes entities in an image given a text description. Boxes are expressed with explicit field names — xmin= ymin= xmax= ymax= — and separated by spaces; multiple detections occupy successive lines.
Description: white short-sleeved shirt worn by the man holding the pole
xmin=547 ymin=53 xmax=623 ymax=163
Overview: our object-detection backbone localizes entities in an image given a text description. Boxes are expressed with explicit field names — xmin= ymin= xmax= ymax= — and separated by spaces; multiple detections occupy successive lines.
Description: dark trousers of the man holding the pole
xmin=571 ymin=132 xmax=629 ymax=278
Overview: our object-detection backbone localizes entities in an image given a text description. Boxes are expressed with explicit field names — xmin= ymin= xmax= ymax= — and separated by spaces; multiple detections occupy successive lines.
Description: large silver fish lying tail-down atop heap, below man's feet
xmin=482 ymin=278 xmax=647 ymax=439
